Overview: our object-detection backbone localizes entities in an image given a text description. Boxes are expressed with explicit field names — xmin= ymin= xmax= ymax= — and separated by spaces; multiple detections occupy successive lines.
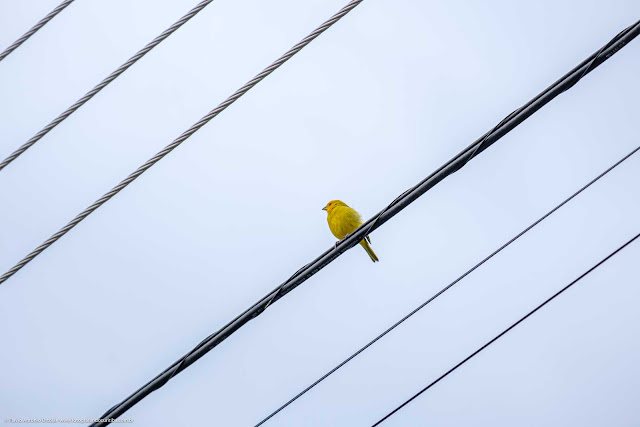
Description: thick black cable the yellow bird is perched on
xmin=87 ymin=21 xmax=640 ymax=426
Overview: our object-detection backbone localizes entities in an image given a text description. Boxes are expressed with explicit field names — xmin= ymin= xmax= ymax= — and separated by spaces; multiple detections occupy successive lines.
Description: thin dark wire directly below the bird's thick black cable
xmin=255 ymin=146 xmax=640 ymax=427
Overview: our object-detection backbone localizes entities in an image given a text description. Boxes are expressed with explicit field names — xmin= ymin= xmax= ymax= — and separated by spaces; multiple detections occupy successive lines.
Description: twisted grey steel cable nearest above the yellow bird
xmin=0 ymin=0 xmax=363 ymax=284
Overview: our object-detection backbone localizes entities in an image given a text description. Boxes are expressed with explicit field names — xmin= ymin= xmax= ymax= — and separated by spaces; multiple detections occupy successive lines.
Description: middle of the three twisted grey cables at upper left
xmin=0 ymin=0 xmax=214 ymax=171
